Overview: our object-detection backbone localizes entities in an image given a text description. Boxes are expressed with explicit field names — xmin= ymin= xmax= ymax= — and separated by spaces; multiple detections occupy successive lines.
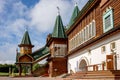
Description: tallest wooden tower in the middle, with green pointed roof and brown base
xmin=47 ymin=8 xmax=67 ymax=77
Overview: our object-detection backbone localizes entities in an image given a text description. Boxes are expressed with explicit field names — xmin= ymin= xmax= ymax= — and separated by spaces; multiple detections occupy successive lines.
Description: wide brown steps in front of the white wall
xmin=65 ymin=70 xmax=120 ymax=80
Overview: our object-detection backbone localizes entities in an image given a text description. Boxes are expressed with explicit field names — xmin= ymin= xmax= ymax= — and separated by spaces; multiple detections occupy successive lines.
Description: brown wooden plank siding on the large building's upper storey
xmin=67 ymin=0 xmax=120 ymax=53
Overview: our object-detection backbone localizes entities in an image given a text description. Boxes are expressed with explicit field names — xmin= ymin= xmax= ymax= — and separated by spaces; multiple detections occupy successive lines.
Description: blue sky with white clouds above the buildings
xmin=0 ymin=0 xmax=88 ymax=64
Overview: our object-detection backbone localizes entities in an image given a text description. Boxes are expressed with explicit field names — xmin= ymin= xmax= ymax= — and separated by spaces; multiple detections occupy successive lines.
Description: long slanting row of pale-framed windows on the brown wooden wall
xmin=69 ymin=20 xmax=96 ymax=50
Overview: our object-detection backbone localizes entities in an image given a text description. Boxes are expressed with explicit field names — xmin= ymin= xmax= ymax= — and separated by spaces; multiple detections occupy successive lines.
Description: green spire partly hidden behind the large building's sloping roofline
xmin=68 ymin=5 xmax=79 ymax=28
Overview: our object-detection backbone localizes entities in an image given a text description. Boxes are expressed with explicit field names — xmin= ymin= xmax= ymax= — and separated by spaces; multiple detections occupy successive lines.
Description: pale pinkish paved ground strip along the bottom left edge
xmin=0 ymin=77 xmax=67 ymax=80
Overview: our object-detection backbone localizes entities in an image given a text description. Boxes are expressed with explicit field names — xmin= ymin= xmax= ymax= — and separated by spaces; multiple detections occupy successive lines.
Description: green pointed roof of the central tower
xmin=52 ymin=15 xmax=67 ymax=38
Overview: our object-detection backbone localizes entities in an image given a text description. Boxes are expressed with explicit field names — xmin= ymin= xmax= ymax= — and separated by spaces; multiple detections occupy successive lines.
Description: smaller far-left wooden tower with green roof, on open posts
xmin=16 ymin=31 xmax=34 ymax=76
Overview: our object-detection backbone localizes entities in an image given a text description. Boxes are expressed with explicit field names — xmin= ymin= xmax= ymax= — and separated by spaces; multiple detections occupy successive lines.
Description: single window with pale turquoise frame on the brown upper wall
xmin=103 ymin=7 xmax=113 ymax=32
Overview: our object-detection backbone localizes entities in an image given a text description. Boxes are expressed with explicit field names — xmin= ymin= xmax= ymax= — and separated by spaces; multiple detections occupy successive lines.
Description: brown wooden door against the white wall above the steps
xmin=106 ymin=55 xmax=114 ymax=70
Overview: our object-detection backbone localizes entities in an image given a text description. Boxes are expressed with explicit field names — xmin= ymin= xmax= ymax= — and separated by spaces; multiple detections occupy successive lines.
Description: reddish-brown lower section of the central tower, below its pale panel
xmin=49 ymin=58 xmax=67 ymax=77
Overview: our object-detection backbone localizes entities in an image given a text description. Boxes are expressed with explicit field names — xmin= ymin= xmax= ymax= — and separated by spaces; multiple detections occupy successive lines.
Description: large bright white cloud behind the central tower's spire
xmin=30 ymin=0 xmax=71 ymax=32
